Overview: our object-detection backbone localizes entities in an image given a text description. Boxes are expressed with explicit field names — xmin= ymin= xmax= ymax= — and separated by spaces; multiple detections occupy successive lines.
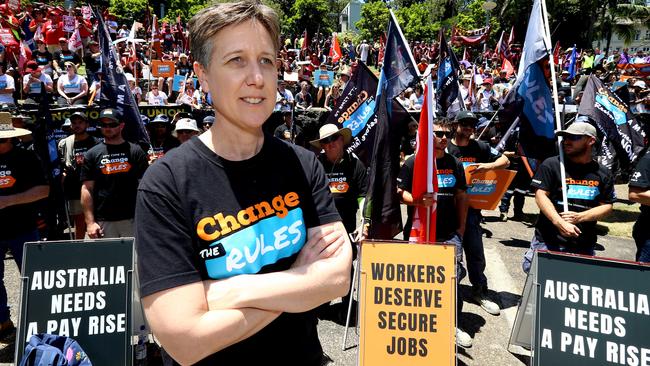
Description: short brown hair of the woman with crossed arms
xmin=188 ymin=0 xmax=280 ymax=68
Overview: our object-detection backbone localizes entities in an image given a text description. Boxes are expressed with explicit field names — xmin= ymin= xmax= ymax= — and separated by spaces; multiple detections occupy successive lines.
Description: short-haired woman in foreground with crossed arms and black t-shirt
xmin=136 ymin=1 xmax=352 ymax=366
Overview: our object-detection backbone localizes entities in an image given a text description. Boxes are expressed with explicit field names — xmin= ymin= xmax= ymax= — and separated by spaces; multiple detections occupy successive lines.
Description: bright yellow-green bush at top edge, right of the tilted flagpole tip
xmin=395 ymin=2 xmax=440 ymax=42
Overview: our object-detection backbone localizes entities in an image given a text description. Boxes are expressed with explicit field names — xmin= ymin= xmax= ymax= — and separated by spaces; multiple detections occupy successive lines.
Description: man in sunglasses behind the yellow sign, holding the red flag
xmin=397 ymin=119 xmax=472 ymax=348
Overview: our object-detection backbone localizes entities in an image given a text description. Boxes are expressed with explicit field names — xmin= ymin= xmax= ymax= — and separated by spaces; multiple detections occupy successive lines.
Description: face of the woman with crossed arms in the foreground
xmin=194 ymin=21 xmax=277 ymax=131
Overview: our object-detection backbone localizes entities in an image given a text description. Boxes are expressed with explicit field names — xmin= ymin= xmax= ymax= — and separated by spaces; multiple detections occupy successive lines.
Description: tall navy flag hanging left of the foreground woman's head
xmin=95 ymin=9 xmax=149 ymax=144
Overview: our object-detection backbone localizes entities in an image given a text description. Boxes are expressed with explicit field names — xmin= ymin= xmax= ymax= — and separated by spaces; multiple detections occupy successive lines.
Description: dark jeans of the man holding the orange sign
xmin=463 ymin=208 xmax=488 ymax=292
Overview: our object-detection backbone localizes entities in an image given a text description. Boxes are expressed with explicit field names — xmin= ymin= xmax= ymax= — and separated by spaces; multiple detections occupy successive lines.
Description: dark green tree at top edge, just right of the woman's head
xmin=287 ymin=0 xmax=338 ymax=35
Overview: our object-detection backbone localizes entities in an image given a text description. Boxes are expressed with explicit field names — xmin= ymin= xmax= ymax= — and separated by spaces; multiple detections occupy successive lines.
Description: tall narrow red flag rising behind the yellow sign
xmin=409 ymin=76 xmax=438 ymax=243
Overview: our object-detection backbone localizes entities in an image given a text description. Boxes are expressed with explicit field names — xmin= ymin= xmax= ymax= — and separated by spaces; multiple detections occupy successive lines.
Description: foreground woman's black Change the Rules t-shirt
xmin=136 ymin=135 xmax=341 ymax=365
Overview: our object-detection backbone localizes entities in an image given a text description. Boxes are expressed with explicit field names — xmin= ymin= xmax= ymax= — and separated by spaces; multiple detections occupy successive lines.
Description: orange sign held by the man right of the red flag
xmin=465 ymin=165 xmax=517 ymax=210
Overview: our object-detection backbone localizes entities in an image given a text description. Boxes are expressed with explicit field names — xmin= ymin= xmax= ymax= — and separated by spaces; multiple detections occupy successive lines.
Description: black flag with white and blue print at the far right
xmin=578 ymin=75 xmax=646 ymax=170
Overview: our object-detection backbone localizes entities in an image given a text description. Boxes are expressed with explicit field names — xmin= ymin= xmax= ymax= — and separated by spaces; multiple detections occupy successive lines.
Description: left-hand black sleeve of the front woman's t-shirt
xmin=135 ymin=162 xmax=202 ymax=296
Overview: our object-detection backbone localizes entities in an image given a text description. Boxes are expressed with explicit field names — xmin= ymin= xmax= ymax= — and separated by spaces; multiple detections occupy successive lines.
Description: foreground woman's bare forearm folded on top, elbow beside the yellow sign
xmin=204 ymin=221 xmax=352 ymax=313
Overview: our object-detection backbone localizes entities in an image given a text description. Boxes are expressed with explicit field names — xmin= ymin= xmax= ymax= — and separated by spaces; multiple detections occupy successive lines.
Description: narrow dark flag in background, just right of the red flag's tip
xmin=436 ymin=30 xmax=459 ymax=116
